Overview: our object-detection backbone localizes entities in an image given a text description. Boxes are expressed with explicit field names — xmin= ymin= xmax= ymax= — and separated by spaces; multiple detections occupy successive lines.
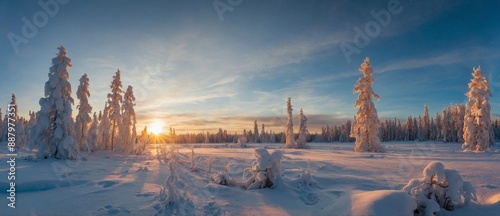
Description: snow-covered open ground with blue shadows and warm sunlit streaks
xmin=0 ymin=142 xmax=500 ymax=216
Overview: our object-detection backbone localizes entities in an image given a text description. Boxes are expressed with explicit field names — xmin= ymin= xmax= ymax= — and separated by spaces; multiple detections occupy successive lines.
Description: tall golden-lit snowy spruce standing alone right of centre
xmin=353 ymin=57 xmax=383 ymax=152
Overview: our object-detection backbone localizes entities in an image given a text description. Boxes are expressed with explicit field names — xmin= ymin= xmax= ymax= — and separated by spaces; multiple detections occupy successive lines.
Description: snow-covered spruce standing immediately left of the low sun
xmin=120 ymin=86 xmax=140 ymax=154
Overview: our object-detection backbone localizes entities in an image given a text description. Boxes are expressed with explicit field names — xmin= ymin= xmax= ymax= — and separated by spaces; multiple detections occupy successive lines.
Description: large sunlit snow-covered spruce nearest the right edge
xmin=462 ymin=67 xmax=491 ymax=151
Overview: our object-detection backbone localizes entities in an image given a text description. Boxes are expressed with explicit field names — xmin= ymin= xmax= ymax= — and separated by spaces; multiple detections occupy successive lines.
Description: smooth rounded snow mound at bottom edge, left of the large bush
xmin=352 ymin=190 xmax=417 ymax=216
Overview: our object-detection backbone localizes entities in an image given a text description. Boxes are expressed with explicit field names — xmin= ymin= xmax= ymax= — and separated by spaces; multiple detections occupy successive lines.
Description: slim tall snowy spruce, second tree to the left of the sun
xmin=108 ymin=69 xmax=123 ymax=151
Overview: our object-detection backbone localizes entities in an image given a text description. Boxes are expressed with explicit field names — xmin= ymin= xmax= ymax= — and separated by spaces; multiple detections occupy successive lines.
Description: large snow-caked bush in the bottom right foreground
xmin=403 ymin=161 xmax=476 ymax=215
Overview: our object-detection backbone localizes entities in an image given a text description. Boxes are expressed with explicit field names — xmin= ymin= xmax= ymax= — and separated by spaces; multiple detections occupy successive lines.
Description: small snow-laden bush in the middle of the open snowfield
xmin=243 ymin=148 xmax=283 ymax=190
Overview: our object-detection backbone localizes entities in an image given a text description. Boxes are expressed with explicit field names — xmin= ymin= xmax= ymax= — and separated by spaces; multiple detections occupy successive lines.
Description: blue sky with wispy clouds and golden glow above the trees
xmin=0 ymin=0 xmax=500 ymax=132
